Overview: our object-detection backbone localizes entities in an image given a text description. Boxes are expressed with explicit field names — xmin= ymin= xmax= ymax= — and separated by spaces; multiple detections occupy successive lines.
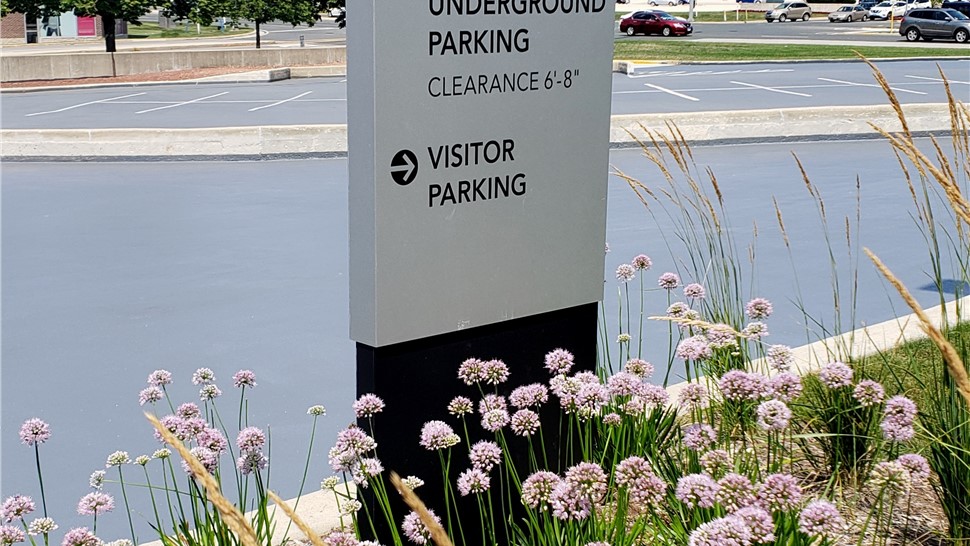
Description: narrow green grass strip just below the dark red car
xmin=613 ymin=38 xmax=970 ymax=61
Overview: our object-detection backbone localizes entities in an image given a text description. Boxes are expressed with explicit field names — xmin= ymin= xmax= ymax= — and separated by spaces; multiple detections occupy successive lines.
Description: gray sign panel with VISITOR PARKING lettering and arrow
xmin=347 ymin=0 xmax=614 ymax=347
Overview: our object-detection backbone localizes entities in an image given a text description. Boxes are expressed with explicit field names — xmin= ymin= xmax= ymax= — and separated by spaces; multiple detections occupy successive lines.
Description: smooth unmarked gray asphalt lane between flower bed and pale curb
xmin=0 ymin=141 xmax=960 ymax=539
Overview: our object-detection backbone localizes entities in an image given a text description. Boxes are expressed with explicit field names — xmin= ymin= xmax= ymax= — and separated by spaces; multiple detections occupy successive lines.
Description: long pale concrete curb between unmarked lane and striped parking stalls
xmin=0 ymin=103 xmax=950 ymax=161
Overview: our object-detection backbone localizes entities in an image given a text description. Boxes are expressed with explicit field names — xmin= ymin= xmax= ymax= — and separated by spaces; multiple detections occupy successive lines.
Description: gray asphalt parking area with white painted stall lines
xmin=0 ymin=59 xmax=970 ymax=129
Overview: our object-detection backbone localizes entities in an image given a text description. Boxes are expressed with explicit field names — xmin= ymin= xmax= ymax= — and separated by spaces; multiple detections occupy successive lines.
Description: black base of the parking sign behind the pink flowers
xmin=357 ymin=303 xmax=598 ymax=546
